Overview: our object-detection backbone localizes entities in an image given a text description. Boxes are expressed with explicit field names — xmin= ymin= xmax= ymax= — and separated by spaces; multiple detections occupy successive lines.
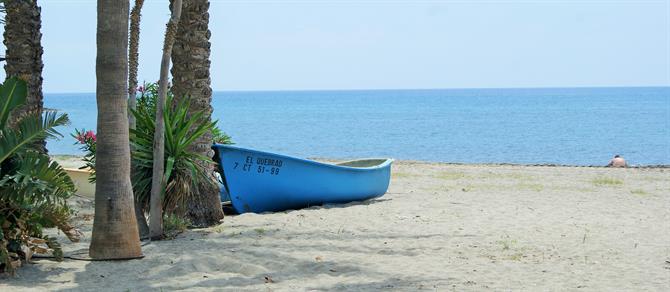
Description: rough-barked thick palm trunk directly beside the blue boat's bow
xmin=172 ymin=0 xmax=223 ymax=227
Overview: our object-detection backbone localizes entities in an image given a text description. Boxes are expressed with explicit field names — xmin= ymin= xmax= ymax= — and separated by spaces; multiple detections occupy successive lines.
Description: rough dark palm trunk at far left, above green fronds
xmin=4 ymin=0 xmax=46 ymax=151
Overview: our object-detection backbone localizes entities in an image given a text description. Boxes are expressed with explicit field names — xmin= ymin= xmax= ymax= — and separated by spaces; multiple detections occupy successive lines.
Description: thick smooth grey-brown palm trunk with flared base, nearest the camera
xmin=89 ymin=0 xmax=142 ymax=259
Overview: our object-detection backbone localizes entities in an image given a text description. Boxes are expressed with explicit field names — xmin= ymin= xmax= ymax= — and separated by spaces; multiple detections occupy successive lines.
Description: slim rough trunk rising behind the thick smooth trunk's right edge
xmin=128 ymin=0 xmax=149 ymax=238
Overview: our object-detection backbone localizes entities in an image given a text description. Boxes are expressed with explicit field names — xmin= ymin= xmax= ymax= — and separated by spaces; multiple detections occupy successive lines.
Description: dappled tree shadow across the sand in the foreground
xmin=9 ymin=219 xmax=451 ymax=291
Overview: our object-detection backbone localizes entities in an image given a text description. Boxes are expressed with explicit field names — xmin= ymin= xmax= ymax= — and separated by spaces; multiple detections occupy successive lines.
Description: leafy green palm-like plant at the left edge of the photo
xmin=0 ymin=77 xmax=78 ymax=273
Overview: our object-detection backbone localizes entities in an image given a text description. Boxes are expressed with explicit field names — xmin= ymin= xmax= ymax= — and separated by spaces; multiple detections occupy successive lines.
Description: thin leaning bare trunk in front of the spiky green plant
xmin=149 ymin=0 xmax=182 ymax=239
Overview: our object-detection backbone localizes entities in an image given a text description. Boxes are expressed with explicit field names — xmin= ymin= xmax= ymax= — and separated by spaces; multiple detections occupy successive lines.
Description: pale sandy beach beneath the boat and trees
xmin=0 ymin=162 xmax=670 ymax=291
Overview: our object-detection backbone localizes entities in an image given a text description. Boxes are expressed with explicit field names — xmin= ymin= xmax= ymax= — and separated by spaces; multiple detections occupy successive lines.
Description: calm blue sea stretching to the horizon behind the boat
xmin=44 ymin=87 xmax=670 ymax=165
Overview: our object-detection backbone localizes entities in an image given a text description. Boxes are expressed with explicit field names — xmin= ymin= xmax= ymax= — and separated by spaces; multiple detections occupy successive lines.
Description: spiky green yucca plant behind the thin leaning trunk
xmin=131 ymin=84 xmax=216 ymax=216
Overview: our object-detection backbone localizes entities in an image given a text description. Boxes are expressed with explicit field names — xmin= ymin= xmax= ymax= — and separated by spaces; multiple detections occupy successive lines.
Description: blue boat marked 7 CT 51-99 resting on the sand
xmin=212 ymin=144 xmax=393 ymax=214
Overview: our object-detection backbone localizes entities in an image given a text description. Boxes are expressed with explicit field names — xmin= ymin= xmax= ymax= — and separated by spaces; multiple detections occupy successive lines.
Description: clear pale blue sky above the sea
xmin=3 ymin=0 xmax=670 ymax=92
